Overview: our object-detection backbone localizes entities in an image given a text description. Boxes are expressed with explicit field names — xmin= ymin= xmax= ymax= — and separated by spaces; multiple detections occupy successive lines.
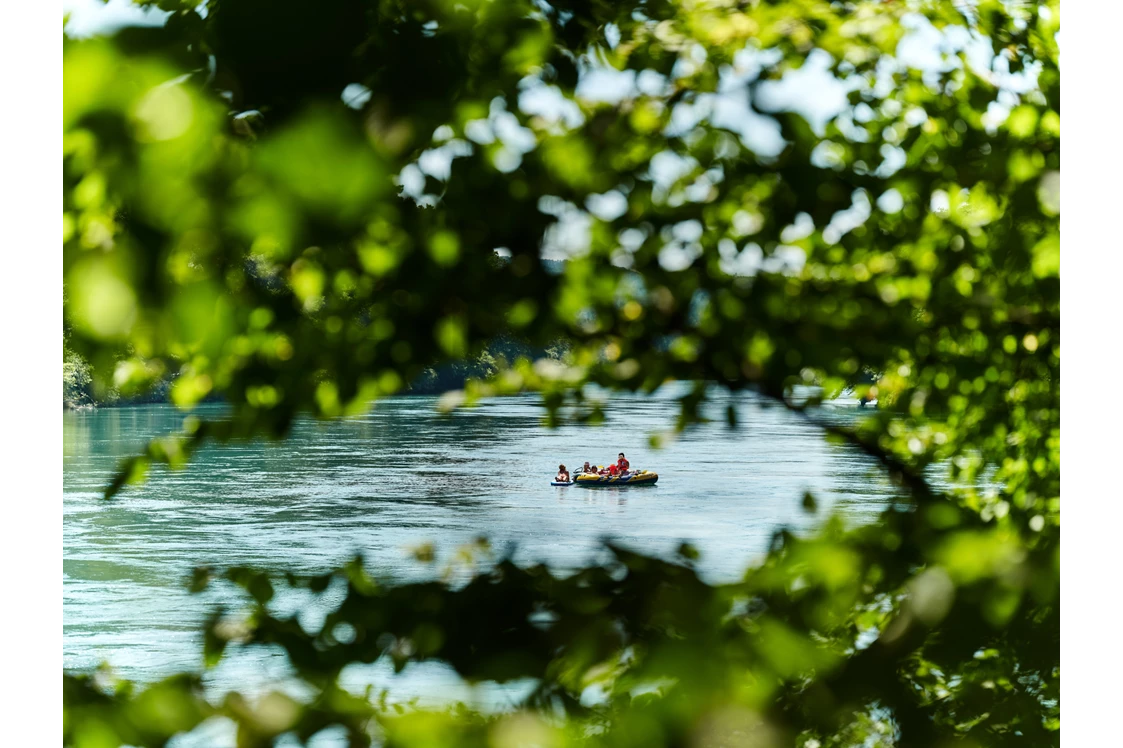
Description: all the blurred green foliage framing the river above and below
xmin=63 ymin=0 xmax=1060 ymax=748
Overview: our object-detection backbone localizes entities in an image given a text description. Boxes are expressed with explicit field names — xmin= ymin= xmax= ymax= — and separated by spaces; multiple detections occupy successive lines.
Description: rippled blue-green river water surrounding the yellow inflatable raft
xmin=63 ymin=391 xmax=892 ymax=702
